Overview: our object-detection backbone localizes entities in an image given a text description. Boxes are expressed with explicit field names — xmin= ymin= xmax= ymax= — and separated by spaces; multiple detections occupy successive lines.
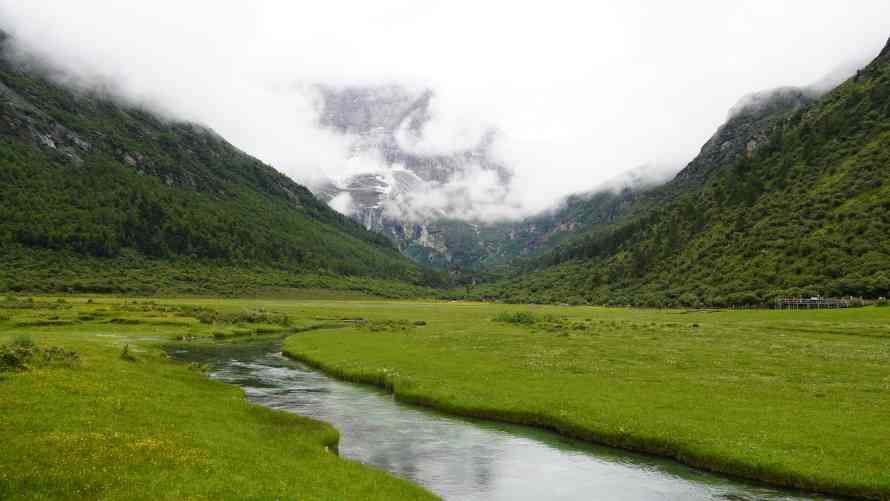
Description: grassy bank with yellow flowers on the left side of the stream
xmin=0 ymin=298 xmax=434 ymax=500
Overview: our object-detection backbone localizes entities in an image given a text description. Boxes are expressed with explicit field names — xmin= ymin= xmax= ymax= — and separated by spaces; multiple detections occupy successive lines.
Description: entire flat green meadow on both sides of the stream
xmin=0 ymin=296 xmax=890 ymax=499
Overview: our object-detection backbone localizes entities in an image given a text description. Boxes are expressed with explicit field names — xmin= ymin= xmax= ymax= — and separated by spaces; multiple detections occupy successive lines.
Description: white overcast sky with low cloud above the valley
xmin=0 ymin=0 xmax=890 ymax=216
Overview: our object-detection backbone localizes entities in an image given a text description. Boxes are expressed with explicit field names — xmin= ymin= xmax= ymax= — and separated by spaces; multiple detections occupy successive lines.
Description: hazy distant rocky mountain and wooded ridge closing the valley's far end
xmin=314 ymin=86 xmax=664 ymax=270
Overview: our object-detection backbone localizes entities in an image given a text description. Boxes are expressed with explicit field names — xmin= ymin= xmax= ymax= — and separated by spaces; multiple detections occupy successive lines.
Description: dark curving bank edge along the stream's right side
xmin=282 ymin=336 xmax=890 ymax=500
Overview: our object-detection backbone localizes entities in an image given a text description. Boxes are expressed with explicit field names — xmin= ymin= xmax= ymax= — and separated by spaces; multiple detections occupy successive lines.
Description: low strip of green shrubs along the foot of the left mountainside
xmin=0 ymin=246 xmax=437 ymax=296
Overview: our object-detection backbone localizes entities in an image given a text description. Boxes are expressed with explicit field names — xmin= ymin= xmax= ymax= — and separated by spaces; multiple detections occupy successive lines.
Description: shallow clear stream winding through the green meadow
xmin=173 ymin=342 xmax=827 ymax=501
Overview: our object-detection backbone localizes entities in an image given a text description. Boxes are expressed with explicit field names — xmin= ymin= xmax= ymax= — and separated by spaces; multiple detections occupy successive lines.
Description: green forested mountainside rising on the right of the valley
xmin=474 ymin=38 xmax=890 ymax=305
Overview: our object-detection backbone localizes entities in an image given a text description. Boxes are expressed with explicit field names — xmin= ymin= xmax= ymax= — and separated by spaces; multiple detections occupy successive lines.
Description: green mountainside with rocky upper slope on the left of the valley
xmin=0 ymin=31 xmax=438 ymax=290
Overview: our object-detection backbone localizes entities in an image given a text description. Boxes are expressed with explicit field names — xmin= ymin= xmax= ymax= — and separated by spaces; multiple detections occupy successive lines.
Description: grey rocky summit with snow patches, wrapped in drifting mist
xmin=317 ymin=84 xmax=521 ymax=229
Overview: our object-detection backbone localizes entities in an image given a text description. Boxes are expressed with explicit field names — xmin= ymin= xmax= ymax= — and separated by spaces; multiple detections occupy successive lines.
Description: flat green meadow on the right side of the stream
xmin=285 ymin=303 xmax=890 ymax=499
